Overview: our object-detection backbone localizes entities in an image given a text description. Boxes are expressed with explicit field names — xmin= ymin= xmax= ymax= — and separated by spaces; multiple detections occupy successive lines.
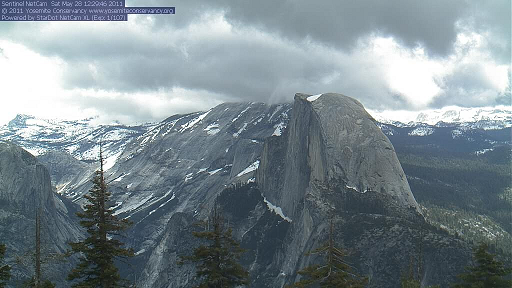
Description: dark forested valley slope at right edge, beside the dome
xmin=398 ymin=146 xmax=512 ymax=257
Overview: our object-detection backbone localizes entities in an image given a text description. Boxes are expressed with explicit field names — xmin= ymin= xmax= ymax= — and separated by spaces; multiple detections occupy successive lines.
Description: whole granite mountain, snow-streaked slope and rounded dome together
xmin=1 ymin=94 xmax=504 ymax=287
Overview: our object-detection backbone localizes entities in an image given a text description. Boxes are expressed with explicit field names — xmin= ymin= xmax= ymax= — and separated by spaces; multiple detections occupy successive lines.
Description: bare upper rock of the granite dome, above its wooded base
xmin=257 ymin=93 xmax=420 ymax=216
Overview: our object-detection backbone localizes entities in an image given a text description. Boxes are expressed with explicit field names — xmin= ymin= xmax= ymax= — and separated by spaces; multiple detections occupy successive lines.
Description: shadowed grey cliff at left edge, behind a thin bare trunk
xmin=0 ymin=141 xmax=81 ymax=287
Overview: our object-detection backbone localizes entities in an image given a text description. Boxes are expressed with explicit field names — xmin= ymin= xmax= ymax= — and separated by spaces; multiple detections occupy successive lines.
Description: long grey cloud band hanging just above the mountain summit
xmin=53 ymin=26 xmax=398 ymax=106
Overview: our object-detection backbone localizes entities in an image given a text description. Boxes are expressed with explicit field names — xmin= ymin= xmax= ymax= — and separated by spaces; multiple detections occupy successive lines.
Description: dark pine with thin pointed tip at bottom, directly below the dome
xmin=289 ymin=220 xmax=368 ymax=288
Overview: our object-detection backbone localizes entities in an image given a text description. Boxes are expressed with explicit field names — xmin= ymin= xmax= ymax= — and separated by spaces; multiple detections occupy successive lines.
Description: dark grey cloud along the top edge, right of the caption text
xmin=220 ymin=0 xmax=467 ymax=54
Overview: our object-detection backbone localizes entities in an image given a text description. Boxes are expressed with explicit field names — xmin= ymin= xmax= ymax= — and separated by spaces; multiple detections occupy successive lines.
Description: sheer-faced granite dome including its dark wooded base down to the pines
xmin=255 ymin=93 xmax=469 ymax=287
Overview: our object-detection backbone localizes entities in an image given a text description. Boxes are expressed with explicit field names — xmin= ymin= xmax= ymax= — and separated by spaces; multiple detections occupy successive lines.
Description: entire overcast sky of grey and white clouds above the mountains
xmin=0 ymin=0 xmax=511 ymax=124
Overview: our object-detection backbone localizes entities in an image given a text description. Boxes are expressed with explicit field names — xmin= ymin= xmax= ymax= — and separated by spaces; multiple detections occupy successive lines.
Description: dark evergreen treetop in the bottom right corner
xmin=452 ymin=243 xmax=512 ymax=288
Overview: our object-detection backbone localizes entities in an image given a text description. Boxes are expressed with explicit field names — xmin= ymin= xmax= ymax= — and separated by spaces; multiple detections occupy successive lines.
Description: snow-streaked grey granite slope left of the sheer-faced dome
xmin=82 ymin=103 xmax=291 ymax=288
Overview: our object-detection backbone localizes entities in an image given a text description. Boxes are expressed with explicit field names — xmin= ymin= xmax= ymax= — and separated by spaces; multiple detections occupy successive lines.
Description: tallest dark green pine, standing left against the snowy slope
xmin=68 ymin=148 xmax=134 ymax=288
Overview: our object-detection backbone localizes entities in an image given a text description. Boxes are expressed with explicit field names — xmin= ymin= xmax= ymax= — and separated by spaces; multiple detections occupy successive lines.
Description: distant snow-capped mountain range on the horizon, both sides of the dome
xmin=0 ymin=104 xmax=512 ymax=169
